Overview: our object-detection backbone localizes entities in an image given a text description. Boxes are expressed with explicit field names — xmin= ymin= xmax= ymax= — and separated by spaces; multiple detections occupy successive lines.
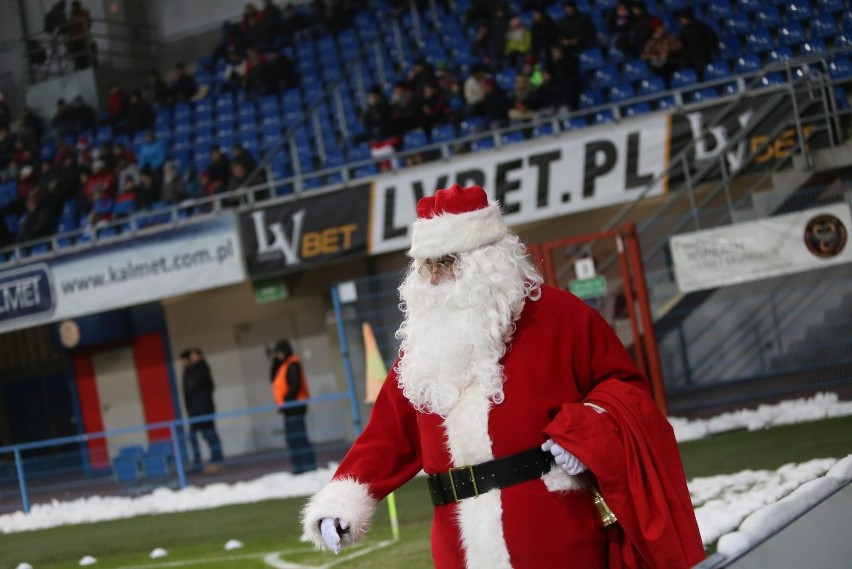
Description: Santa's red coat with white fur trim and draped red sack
xmin=305 ymin=287 xmax=704 ymax=569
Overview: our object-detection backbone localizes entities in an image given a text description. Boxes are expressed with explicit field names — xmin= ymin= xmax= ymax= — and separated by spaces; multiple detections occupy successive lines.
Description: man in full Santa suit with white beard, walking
xmin=302 ymin=185 xmax=704 ymax=569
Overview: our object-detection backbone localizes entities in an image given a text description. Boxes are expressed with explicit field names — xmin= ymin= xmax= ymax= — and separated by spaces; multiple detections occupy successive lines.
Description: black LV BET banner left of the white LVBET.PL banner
xmin=240 ymin=184 xmax=370 ymax=278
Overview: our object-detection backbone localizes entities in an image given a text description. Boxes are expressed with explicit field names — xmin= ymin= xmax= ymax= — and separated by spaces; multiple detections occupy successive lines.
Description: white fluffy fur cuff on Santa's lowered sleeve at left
xmin=302 ymin=477 xmax=376 ymax=550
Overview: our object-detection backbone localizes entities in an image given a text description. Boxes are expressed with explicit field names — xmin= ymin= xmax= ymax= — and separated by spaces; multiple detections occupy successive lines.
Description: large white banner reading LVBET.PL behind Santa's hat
xmin=370 ymin=113 xmax=669 ymax=254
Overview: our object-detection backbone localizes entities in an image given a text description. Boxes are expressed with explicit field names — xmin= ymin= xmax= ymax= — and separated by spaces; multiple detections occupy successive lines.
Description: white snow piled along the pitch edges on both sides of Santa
xmin=0 ymin=394 xmax=852 ymax=551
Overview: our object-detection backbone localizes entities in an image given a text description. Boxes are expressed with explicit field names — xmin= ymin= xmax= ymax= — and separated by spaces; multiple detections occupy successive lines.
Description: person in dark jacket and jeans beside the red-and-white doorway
xmin=180 ymin=348 xmax=223 ymax=474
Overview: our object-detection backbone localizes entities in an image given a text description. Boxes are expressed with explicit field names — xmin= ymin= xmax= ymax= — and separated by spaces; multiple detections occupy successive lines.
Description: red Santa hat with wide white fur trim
xmin=408 ymin=184 xmax=509 ymax=259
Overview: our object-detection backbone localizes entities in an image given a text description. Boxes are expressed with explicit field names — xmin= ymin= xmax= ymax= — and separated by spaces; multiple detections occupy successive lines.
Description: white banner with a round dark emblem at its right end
xmin=670 ymin=204 xmax=852 ymax=293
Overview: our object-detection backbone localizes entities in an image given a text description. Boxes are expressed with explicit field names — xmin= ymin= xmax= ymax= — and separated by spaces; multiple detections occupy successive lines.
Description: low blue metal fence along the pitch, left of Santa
xmin=0 ymin=390 xmax=354 ymax=514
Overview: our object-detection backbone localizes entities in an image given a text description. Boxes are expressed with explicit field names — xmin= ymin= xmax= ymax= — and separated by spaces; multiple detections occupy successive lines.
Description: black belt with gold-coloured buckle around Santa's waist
xmin=426 ymin=447 xmax=553 ymax=506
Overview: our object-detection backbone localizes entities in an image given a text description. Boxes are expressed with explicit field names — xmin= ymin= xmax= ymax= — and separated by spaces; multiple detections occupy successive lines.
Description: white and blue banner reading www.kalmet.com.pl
xmin=0 ymin=213 xmax=245 ymax=333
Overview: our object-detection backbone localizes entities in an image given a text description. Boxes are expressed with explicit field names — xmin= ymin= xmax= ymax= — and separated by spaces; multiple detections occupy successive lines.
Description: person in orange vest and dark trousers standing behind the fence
xmin=269 ymin=340 xmax=317 ymax=474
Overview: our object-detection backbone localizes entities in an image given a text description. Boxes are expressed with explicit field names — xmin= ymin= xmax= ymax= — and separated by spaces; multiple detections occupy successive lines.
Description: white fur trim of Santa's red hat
xmin=408 ymin=201 xmax=509 ymax=259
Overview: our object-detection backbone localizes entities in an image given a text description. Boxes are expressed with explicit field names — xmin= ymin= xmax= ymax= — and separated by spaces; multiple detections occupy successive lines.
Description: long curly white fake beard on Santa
xmin=396 ymin=237 xmax=538 ymax=417
